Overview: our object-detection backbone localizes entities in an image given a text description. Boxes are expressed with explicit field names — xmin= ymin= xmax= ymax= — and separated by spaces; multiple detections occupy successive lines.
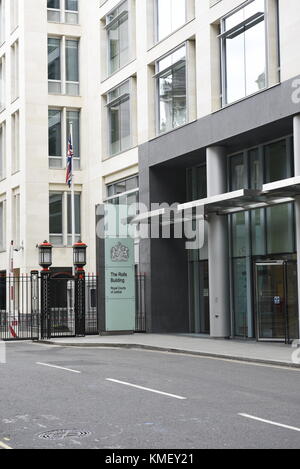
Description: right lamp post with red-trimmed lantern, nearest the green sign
xmin=73 ymin=241 xmax=87 ymax=336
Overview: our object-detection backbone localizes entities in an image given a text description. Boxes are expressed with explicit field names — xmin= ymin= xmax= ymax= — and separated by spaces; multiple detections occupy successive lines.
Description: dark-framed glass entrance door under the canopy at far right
xmin=256 ymin=261 xmax=288 ymax=341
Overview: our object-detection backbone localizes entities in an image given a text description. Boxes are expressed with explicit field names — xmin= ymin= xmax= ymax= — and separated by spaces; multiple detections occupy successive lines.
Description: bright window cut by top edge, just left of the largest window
xmin=156 ymin=0 xmax=187 ymax=41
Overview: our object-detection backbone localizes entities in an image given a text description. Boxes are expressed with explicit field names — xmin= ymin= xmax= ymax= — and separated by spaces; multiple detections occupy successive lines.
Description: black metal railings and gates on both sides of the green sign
xmin=0 ymin=271 xmax=146 ymax=341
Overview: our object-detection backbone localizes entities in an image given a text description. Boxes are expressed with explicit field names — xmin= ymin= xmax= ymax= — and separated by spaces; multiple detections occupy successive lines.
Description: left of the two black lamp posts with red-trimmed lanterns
xmin=38 ymin=241 xmax=52 ymax=339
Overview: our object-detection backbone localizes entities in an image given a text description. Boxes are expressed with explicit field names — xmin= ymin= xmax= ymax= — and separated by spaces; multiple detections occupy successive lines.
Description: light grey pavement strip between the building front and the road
xmin=38 ymin=334 xmax=300 ymax=368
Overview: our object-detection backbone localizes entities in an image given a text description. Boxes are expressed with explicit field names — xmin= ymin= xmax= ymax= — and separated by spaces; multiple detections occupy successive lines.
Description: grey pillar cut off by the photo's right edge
xmin=294 ymin=114 xmax=300 ymax=338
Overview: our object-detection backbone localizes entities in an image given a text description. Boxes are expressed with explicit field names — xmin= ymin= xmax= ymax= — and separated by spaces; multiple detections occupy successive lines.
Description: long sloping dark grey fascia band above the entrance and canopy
xmin=139 ymin=77 xmax=300 ymax=170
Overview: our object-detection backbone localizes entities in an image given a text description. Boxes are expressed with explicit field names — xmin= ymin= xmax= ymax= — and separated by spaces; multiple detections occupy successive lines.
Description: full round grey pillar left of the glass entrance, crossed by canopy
xmin=206 ymin=147 xmax=230 ymax=338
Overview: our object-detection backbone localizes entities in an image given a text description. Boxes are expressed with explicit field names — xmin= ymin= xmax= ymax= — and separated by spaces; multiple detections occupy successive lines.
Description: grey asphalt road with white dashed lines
xmin=0 ymin=342 xmax=300 ymax=449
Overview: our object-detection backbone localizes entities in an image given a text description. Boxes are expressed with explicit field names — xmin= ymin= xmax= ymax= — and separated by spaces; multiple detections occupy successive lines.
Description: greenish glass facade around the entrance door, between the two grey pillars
xmin=228 ymin=137 xmax=297 ymax=339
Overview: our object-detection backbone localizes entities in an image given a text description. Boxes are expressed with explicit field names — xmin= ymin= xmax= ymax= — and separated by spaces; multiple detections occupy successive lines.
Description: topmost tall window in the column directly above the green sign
xmin=106 ymin=1 xmax=129 ymax=75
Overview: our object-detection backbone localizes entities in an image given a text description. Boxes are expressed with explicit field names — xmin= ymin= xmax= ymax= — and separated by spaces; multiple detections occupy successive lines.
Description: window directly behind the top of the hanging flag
xmin=48 ymin=108 xmax=80 ymax=170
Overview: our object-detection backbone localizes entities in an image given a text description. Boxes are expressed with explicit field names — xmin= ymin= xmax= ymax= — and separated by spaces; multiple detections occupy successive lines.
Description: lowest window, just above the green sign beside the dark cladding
xmin=106 ymin=176 xmax=139 ymax=205
